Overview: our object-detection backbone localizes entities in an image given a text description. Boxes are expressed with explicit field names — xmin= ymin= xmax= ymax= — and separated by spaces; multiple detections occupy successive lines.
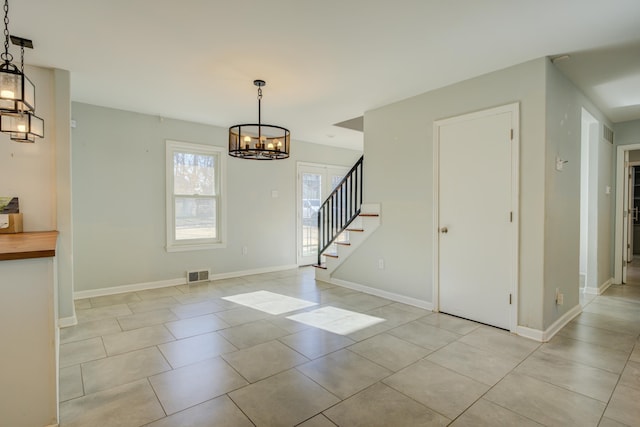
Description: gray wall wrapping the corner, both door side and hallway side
xmin=334 ymin=58 xmax=612 ymax=330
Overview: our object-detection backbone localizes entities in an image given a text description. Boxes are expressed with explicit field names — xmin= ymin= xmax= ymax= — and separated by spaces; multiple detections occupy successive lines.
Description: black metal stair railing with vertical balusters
xmin=318 ymin=156 xmax=364 ymax=265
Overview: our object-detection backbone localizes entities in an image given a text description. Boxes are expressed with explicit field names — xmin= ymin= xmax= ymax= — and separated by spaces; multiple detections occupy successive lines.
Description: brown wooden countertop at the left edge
xmin=0 ymin=231 xmax=58 ymax=261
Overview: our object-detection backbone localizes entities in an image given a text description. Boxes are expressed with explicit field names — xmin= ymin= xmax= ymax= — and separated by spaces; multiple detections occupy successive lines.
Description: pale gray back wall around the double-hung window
xmin=72 ymin=103 xmax=361 ymax=291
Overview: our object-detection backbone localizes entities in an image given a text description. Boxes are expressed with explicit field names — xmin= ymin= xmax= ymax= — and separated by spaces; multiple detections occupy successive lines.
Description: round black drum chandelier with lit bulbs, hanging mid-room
xmin=229 ymin=80 xmax=291 ymax=160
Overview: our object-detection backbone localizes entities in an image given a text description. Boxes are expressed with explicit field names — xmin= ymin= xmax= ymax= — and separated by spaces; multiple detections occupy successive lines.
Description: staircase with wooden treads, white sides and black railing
xmin=314 ymin=156 xmax=380 ymax=281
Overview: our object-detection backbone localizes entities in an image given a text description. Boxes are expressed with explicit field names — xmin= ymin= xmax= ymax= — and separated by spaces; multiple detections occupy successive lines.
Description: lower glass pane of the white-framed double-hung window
xmin=175 ymin=197 xmax=218 ymax=240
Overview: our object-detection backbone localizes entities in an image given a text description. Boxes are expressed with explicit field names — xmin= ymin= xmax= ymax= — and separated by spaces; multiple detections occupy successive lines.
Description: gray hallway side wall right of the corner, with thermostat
xmin=543 ymin=61 xmax=614 ymax=328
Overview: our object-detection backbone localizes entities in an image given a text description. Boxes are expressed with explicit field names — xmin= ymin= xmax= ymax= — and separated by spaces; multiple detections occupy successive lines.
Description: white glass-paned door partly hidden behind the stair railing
xmin=297 ymin=163 xmax=349 ymax=265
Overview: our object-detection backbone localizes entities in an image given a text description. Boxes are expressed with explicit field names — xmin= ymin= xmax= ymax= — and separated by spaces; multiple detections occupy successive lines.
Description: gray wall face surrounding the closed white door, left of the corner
xmin=335 ymin=59 xmax=546 ymax=329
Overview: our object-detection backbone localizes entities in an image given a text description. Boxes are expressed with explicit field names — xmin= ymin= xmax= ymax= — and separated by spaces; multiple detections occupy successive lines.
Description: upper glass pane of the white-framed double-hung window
xmin=173 ymin=152 xmax=216 ymax=196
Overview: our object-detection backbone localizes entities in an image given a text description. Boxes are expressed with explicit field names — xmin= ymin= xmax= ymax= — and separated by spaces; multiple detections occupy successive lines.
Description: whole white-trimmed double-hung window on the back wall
xmin=166 ymin=141 xmax=226 ymax=252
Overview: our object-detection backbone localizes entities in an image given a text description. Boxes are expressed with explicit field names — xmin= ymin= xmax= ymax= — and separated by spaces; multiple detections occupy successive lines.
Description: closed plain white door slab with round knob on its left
xmin=436 ymin=105 xmax=518 ymax=329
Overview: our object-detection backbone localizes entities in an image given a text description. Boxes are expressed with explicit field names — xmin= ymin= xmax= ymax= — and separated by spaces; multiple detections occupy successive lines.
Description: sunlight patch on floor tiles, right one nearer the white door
xmin=287 ymin=306 xmax=385 ymax=335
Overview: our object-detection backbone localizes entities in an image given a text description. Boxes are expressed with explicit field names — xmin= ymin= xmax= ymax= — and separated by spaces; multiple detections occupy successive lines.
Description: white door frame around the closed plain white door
xmin=432 ymin=102 xmax=520 ymax=333
